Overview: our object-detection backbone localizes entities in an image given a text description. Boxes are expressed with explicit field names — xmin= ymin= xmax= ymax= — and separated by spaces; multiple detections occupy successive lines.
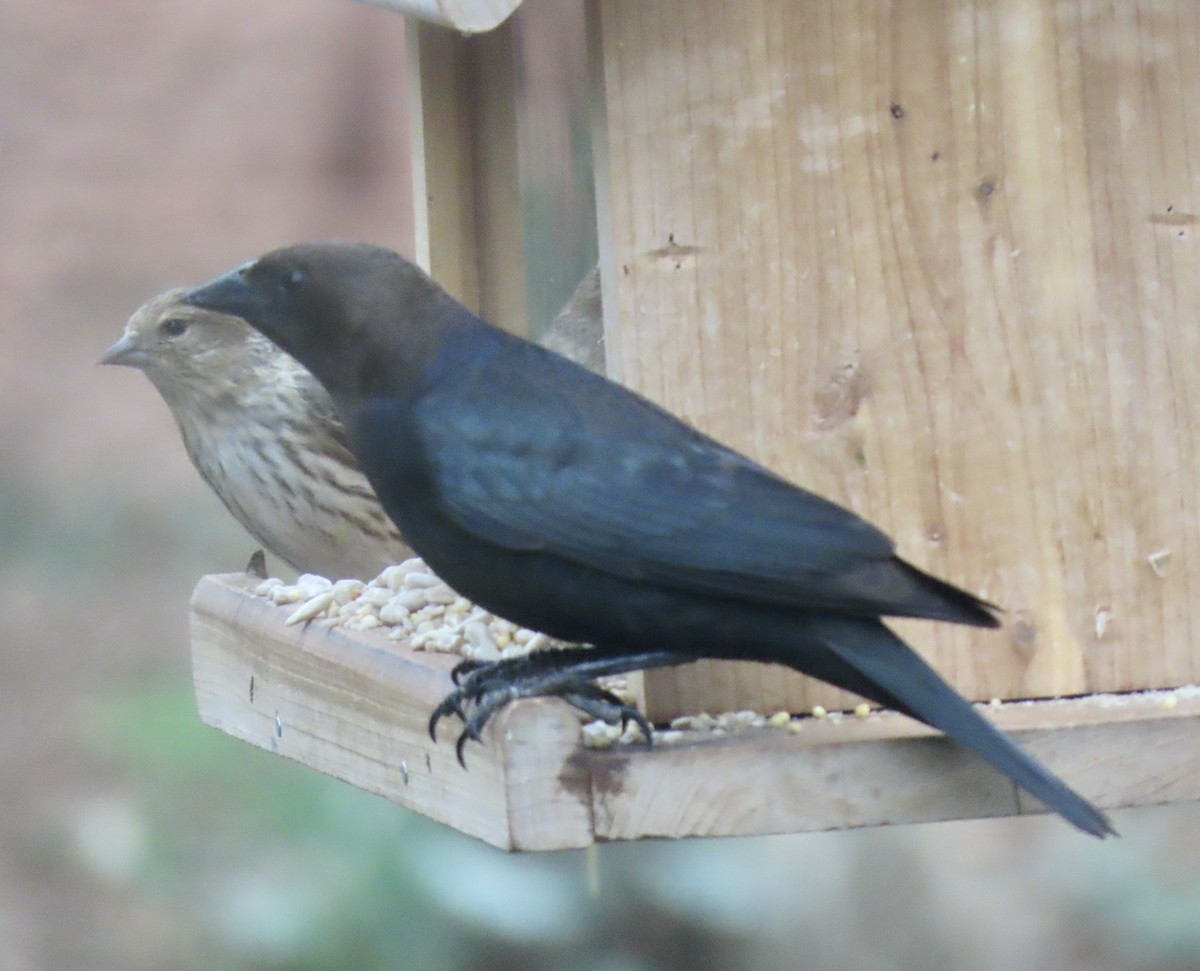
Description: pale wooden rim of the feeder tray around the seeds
xmin=191 ymin=574 xmax=1200 ymax=850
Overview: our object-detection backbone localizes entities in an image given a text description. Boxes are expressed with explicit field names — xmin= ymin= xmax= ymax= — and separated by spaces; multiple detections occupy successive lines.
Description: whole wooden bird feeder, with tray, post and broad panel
xmin=193 ymin=0 xmax=1200 ymax=849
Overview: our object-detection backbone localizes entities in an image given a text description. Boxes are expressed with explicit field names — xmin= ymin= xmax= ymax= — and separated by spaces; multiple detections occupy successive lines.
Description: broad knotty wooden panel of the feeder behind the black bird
xmin=594 ymin=0 xmax=1200 ymax=714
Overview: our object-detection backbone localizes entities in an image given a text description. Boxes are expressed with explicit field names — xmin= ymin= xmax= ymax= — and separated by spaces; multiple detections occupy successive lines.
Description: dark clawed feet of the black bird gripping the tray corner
xmin=430 ymin=648 xmax=690 ymax=768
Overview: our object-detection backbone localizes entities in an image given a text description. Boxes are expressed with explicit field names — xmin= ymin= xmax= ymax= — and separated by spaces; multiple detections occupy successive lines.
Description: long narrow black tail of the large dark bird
xmin=796 ymin=617 xmax=1116 ymax=837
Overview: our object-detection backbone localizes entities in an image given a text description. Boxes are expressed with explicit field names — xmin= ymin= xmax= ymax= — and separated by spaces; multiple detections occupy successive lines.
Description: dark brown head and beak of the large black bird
xmin=182 ymin=242 xmax=461 ymax=398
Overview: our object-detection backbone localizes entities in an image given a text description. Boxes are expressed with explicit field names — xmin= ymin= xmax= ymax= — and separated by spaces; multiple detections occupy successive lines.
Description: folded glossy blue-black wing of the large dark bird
xmin=414 ymin=341 xmax=995 ymax=624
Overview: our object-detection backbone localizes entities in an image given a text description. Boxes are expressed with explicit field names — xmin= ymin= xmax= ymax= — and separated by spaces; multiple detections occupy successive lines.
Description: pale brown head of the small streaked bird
xmin=100 ymin=289 xmax=288 ymax=413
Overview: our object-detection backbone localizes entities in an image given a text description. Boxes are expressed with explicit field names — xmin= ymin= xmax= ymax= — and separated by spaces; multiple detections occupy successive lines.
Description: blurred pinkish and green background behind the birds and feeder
xmin=0 ymin=0 xmax=1200 ymax=971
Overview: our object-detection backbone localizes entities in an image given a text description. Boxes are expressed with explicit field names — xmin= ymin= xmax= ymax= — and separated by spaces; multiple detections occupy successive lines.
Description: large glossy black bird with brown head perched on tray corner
xmin=185 ymin=244 xmax=1114 ymax=835
